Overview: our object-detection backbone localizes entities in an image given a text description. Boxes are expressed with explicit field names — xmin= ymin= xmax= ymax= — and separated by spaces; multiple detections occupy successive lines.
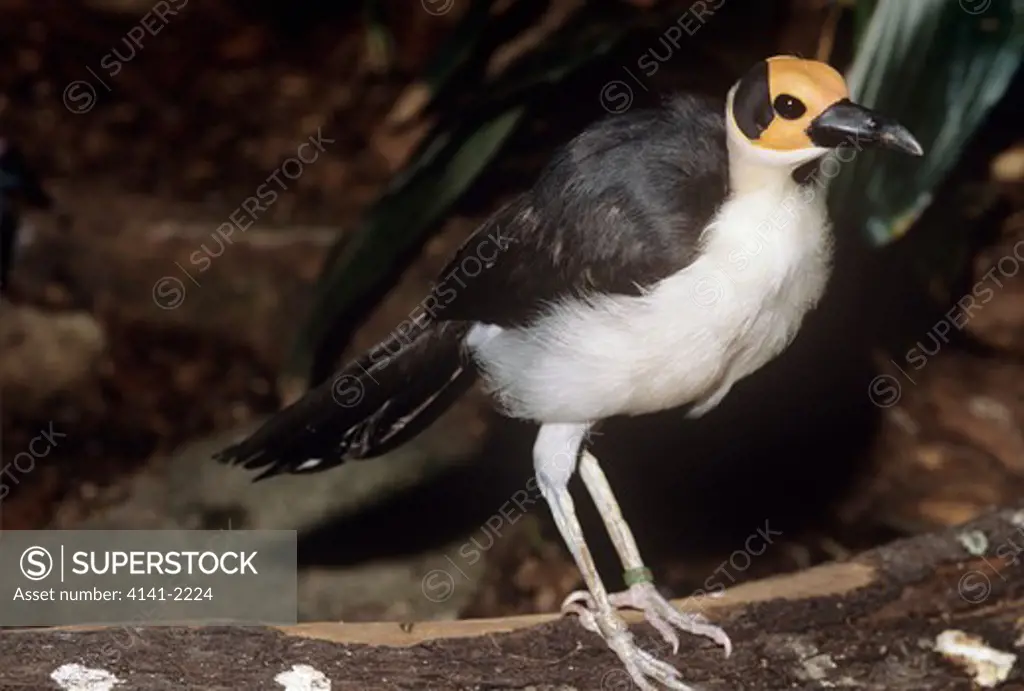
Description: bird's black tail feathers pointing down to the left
xmin=214 ymin=321 xmax=477 ymax=480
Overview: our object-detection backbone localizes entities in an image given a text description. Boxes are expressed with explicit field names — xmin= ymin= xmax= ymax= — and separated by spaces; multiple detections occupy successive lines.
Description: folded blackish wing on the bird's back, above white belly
xmin=425 ymin=96 xmax=728 ymax=327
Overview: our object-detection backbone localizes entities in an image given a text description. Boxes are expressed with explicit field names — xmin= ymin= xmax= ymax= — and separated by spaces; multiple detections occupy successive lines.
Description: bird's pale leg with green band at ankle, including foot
xmin=566 ymin=449 xmax=732 ymax=655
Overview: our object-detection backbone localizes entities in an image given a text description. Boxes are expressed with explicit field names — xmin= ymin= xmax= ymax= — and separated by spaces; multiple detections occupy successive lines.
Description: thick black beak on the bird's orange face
xmin=807 ymin=98 xmax=924 ymax=156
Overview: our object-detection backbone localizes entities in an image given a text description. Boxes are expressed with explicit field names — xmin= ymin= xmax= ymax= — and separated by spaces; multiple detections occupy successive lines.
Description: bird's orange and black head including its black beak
xmin=727 ymin=55 xmax=923 ymax=169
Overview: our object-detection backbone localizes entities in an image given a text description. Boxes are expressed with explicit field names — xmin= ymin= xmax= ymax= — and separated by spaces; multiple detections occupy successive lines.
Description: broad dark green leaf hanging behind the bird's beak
xmin=829 ymin=0 xmax=1024 ymax=245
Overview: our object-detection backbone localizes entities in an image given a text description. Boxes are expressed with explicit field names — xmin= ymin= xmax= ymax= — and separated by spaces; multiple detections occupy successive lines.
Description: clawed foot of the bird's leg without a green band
xmin=562 ymin=591 xmax=694 ymax=691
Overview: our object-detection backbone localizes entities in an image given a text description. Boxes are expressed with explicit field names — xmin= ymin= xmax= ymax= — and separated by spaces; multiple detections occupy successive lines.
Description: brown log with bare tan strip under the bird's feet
xmin=0 ymin=510 xmax=1024 ymax=691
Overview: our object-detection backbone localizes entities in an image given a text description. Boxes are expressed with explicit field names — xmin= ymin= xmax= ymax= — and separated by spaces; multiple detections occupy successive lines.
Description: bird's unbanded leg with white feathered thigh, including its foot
xmin=534 ymin=424 xmax=692 ymax=691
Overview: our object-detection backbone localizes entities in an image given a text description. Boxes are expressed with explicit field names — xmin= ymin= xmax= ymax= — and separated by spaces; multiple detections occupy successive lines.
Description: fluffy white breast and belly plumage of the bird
xmin=467 ymin=183 xmax=831 ymax=423
